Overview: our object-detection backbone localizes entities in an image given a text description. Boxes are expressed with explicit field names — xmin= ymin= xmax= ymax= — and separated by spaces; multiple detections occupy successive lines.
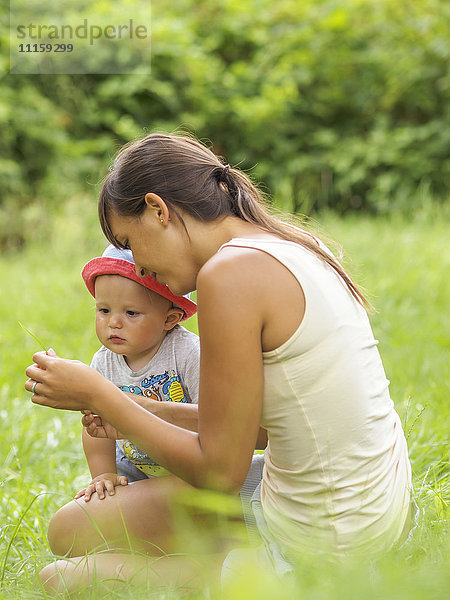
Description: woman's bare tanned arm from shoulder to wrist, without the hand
xmin=110 ymin=248 xmax=263 ymax=491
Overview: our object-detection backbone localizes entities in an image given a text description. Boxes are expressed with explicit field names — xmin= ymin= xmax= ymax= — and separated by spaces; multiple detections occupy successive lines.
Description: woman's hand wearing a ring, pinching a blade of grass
xmin=25 ymin=350 xmax=109 ymax=412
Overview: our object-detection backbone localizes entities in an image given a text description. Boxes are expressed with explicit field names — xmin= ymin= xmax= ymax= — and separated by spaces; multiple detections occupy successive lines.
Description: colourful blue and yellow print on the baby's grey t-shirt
xmin=117 ymin=369 xmax=188 ymax=477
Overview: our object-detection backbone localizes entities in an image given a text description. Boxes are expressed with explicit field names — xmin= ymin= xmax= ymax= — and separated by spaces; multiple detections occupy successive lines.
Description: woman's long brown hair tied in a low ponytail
xmin=98 ymin=133 xmax=370 ymax=307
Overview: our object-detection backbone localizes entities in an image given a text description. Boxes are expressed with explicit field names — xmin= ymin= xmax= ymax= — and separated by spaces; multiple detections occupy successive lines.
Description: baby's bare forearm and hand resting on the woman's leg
xmin=75 ymin=427 xmax=128 ymax=502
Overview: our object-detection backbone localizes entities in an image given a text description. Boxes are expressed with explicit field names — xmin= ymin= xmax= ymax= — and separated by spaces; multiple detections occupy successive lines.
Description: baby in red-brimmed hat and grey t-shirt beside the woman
xmin=75 ymin=245 xmax=200 ymax=502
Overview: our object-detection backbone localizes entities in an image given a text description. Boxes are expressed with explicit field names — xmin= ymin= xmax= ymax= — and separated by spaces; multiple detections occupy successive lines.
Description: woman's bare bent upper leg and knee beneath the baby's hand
xmin=48 ymin=475 xmax=243 ymax=556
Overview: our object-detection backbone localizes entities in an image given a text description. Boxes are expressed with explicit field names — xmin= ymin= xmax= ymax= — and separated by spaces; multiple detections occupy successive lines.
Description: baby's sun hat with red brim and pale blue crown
xmin=81 ymin=244 xmax=197 ymax=321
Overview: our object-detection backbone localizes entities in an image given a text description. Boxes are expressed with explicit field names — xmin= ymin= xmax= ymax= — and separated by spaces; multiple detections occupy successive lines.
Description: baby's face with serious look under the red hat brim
xmin=95 ymin=275 xmax=175 ymax=371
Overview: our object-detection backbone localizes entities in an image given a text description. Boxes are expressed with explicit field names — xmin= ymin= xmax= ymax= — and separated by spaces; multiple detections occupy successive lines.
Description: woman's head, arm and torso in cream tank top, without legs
xmin=26 ymin=134 xmax=411 ymax=592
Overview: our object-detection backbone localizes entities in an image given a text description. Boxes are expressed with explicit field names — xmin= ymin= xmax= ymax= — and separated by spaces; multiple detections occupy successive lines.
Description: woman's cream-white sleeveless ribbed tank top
xmin=221 ymin=238 xmax=411 ymax=553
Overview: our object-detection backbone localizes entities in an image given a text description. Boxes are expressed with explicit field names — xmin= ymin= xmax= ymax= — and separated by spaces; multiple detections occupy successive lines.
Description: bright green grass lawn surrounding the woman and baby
xmin=0 ymin=209 xmax=450 ymax=600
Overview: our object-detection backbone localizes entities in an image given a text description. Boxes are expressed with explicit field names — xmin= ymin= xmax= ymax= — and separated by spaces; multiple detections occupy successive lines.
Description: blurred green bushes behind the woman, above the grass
xmin=0 ymin=0 xmax=450 ymax=248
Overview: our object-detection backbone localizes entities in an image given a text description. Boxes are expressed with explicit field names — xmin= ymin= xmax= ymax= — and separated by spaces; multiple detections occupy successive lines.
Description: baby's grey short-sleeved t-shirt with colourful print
xmin=91 ymin=325 xmax=200 ymax=476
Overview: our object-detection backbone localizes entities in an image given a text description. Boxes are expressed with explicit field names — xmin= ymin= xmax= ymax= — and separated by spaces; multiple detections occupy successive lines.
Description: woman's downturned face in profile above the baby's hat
xmin=108 ymin=206 xmax=198 ymax=296
